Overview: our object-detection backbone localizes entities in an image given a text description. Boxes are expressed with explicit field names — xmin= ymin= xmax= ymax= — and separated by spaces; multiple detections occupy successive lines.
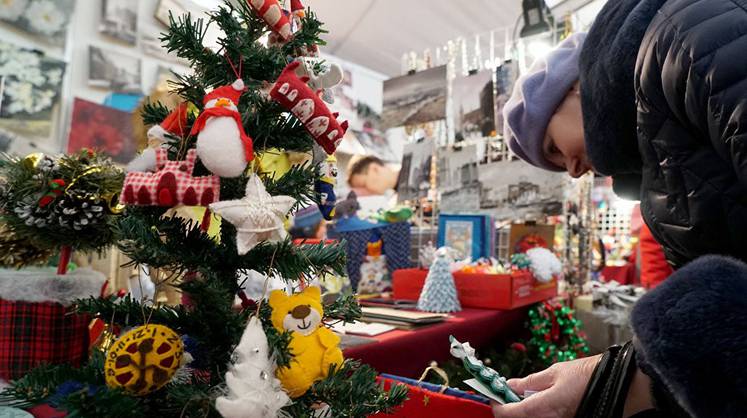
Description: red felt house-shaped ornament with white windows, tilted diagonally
xmin=270 ymin=61 xmax=348 ymax=155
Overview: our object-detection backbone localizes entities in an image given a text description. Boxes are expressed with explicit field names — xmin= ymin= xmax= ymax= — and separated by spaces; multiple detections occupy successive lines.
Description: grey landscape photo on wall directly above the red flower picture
xmin=88 ymin=46 xmax=142 ymax=93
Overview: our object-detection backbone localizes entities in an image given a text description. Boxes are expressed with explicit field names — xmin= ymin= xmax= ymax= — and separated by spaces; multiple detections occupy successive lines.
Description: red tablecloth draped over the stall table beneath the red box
xmin=345 ymin=309 xmax=526 ymax=378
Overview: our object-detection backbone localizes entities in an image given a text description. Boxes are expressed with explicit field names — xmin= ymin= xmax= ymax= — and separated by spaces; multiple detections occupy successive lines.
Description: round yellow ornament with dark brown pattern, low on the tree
xmin=104 ymin=324 xmax=184 ymax=395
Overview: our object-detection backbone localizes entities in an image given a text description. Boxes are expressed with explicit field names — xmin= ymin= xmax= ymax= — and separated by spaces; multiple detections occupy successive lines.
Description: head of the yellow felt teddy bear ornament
xmin=270 ymin=286 xmax=324 ymax=336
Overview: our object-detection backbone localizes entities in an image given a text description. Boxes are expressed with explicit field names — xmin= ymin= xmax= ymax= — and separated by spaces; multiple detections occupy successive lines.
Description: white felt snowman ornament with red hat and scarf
xmin=190 ymin=78 xmax=254 ymax=177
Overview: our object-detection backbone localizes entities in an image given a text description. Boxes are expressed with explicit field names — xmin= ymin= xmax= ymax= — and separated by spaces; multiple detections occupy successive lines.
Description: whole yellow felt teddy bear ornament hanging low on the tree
xmin=269 ymin=286 xmax=343 ymax=398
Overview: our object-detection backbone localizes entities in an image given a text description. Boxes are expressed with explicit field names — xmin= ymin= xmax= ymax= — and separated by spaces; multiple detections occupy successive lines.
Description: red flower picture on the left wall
xmin=67 ymin=98 xmax=137 ymax=164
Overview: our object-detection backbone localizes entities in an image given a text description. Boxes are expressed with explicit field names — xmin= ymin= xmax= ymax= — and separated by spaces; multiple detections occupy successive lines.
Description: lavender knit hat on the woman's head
xmin=503 ymin=33 xmax=586 ymax=171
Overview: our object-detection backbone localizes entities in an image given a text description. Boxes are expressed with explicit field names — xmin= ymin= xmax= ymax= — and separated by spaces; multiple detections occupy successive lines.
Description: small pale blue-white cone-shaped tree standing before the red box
xmin=418 ymin=252 xmax=462 ymax=313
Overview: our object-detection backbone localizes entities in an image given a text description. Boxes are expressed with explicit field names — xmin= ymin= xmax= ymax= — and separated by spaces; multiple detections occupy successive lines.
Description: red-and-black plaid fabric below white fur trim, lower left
xmin=0 ymin=299 xmax=91 ymax=380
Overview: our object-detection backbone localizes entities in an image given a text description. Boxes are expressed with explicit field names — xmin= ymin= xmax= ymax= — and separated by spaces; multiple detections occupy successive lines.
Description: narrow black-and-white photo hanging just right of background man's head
xmin=397 ymin=138 xmax=434 ymax=202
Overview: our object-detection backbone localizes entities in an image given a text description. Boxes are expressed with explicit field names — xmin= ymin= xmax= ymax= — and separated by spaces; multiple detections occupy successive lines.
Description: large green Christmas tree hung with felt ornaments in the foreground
xmin=0 ymin=0 xmax=407 ymax=418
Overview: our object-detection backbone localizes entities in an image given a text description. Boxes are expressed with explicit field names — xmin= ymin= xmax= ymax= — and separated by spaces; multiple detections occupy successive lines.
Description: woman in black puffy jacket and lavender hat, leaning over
xmin=494 ymin=0 xmax=747 ymax=418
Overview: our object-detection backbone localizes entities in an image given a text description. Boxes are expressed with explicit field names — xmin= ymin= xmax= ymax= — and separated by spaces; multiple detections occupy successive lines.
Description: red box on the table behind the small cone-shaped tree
xmin=392 ymin=269 xmax=558 ymax=309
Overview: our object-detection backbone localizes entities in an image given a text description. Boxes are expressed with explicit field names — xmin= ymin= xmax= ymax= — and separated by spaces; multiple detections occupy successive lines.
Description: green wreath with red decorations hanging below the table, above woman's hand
xmin=529 ymin=301 xmax=589 ymax=365
